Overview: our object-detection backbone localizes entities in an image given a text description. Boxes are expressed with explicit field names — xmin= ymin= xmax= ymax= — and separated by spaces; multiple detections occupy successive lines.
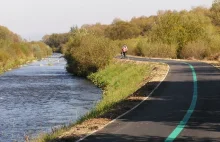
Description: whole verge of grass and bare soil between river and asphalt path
xmin=34 ymin=60 xmax=168 ymax=142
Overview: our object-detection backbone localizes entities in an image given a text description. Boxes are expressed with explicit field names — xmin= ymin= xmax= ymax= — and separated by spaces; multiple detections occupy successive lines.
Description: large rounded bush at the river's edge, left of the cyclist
xmin=65 ymin=33 xmax=116 ymax=76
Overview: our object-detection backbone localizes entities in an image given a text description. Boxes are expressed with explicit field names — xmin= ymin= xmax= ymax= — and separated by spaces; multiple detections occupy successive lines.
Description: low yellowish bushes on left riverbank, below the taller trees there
xmin=0 ymin=42 xmax=52 ymax=72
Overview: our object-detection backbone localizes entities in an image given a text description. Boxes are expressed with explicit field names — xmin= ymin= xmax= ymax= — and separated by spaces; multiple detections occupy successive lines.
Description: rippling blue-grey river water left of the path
xmin=0 ymin=54 xmax=102 ymax=142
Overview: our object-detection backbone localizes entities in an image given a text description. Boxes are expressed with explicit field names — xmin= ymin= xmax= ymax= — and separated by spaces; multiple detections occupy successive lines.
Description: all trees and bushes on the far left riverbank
xmin=0 ymin=26 xmax=52 ymax=73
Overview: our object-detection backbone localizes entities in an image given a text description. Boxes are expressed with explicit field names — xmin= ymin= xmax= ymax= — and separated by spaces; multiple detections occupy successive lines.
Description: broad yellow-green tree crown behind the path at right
xmin=151 ymin=12 xmax=212 ymax=50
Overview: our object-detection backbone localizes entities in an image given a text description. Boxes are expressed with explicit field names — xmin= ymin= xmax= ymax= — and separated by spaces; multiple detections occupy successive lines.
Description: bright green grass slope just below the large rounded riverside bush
xmin=85 ymin=62 xmax=152 ymax=119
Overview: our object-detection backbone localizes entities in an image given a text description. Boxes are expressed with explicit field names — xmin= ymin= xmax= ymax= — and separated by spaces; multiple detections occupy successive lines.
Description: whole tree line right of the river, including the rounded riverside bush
xmin=43 ymin=0 xmax=220 ymax=75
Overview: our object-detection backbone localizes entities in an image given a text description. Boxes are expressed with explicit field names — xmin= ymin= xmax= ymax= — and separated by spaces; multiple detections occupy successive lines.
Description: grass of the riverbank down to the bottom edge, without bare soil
xmin=33 ymin=61 xmax=163 ymax=142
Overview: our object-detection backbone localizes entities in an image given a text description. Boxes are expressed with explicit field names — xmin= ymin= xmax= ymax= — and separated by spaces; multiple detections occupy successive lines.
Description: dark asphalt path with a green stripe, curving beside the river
xmin=82 ymin=57 xmax=220 ymax=142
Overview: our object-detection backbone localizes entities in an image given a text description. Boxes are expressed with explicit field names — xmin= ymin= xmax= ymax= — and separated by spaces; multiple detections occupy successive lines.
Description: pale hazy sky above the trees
xmin=0 ymin=0 xmax=213 ymax=41
